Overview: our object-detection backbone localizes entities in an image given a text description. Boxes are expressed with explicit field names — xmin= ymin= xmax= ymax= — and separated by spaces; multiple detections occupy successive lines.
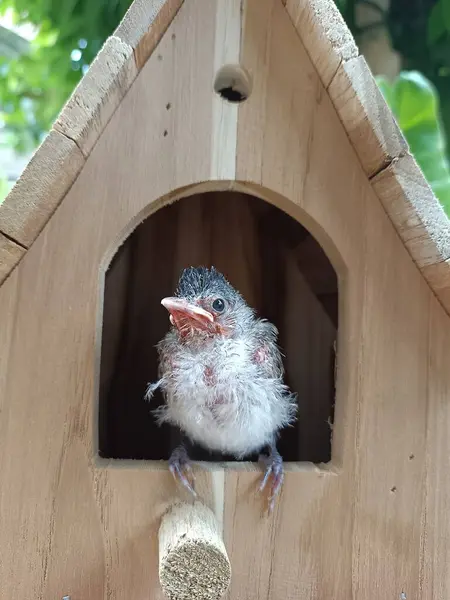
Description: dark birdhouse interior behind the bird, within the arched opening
xmin=99 ymin=192 xmax=338 ymax=463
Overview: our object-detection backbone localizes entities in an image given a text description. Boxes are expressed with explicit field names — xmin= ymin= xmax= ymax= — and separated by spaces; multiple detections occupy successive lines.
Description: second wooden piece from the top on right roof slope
xmin=328 ymin=56 xmax=408 ymax=177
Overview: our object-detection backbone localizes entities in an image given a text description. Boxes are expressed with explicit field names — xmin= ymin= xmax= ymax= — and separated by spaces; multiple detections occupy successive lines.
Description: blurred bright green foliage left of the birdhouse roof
xmin=0 ymin=0 xmax=131 ymax=151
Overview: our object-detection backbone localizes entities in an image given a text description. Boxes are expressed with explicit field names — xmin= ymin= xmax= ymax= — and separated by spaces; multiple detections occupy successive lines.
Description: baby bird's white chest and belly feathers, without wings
xmin=156 ymin=339 xmax=292 ymax=458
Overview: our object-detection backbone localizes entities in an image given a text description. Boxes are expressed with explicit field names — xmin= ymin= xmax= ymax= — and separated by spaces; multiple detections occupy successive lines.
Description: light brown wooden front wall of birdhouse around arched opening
xmin=0 ymin=0 xmax=449 ymax=600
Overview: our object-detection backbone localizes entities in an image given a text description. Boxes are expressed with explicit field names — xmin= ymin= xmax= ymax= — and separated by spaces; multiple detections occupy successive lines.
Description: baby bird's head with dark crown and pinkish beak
xmin=161 ymin=267 xmax=254 ymax=339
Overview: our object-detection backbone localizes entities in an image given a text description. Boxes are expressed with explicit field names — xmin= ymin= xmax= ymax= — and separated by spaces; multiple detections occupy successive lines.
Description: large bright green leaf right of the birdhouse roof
xmin=377 ymin=71 xmax=450 ymax=216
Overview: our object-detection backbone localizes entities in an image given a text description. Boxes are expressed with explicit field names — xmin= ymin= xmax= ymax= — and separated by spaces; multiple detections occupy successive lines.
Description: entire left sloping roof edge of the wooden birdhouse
xmin=0 ymin=0 xmax=184 ymax=283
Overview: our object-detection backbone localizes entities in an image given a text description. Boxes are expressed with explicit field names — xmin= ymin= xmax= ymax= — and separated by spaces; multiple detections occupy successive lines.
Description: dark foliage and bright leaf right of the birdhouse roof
xmin=335 ymin=0 xmax=450 ymax=215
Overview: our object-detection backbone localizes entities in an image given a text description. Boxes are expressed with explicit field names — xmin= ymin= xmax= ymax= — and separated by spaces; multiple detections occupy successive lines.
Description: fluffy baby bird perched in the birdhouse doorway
xmin=146 ymin=267 xmax=297 ymax=511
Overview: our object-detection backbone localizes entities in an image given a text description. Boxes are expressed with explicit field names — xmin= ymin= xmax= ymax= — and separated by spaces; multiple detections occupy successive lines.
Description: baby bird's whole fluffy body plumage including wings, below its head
xmin=147 ymin=318 xmax=297 ymax=458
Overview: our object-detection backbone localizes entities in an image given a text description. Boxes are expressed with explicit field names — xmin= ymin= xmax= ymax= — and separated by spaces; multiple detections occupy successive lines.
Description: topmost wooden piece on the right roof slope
xmin=286 ymin=0 xmax=358 ymax=88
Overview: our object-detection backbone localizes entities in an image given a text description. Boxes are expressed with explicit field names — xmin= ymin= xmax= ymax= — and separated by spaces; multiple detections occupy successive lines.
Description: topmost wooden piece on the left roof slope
xmin=114 ymin=0 xmax=184 ymax=70
